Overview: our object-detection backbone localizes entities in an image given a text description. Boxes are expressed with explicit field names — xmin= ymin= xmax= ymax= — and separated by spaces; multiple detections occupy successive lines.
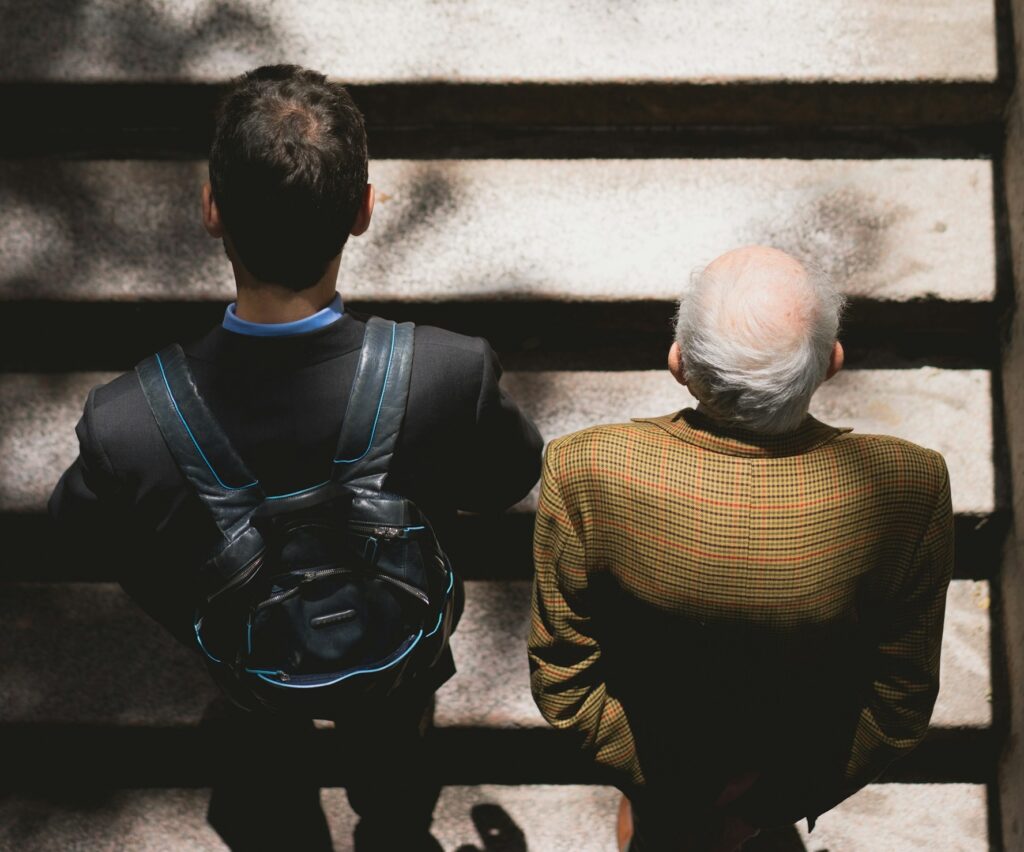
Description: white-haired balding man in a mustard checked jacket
xmin=529 ymin=247 xmax=953 ymax=852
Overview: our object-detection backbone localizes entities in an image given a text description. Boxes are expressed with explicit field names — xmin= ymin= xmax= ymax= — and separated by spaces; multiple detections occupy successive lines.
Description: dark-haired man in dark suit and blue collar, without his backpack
xmin=50 ymin=66 xmax=541 ymax=850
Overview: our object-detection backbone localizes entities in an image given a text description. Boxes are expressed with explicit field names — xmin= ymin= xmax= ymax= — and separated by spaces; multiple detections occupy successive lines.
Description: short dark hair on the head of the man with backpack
xmin=210 ymin=66 xmax=367 ymax=291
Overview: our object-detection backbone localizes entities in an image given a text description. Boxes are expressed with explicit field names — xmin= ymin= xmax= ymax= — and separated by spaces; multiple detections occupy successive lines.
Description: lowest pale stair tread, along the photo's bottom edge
xmin=0 ymin=783 xmax=990 ymax=852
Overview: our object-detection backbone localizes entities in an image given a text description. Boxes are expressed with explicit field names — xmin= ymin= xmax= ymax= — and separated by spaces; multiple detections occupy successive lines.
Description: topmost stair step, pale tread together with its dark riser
xmin=0 ymin=0 xmax=1010 ymax=157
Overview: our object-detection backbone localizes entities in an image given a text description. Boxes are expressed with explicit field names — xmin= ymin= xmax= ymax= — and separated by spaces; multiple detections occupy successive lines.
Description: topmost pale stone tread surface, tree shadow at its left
xmin=0 ymin=0 xmax=996 ymax=83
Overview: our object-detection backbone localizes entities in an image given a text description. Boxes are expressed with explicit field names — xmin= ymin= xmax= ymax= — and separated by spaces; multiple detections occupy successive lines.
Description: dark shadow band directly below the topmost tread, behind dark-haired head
xmin=0 ymin=82 xmax=1008 ymax=160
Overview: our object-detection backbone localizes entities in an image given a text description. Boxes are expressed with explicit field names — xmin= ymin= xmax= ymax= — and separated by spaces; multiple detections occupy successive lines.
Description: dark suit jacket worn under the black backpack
xmin=49 ymin=312 xmax=541 ymax=686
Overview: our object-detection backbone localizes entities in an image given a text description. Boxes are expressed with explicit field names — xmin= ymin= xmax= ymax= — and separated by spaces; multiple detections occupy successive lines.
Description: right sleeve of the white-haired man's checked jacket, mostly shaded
xmin=737 ymin=454 xmax=953 ymax=825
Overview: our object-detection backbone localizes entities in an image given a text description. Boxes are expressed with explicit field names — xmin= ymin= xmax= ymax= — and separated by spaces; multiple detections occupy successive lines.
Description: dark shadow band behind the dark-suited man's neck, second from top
xmin=0 ymin=296 xmax=998 ymax=373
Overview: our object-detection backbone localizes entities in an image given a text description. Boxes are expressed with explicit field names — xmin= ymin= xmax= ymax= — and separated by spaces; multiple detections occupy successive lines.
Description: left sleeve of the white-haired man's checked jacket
xmin=528 ymin=442 xmax=643 ymax=785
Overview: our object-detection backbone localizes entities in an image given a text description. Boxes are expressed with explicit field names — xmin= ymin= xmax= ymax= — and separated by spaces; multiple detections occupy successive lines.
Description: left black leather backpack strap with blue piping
xmin=135 ymin=343 xmax=263 ymax=541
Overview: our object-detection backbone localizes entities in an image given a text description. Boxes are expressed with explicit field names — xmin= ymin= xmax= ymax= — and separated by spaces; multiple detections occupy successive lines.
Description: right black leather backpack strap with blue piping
xmin=332 ymin=316 xmax=415 ymax=491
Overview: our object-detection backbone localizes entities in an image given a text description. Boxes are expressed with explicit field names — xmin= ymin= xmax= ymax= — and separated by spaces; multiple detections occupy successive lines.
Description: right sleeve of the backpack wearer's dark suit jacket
xmin=456 ymin=340 xmax=543 ymax=512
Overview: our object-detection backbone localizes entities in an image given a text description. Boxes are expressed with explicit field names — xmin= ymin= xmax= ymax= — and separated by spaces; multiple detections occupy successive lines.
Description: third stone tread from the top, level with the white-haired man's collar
xmin=0 ymin=366 xmax=998 ymax=514
